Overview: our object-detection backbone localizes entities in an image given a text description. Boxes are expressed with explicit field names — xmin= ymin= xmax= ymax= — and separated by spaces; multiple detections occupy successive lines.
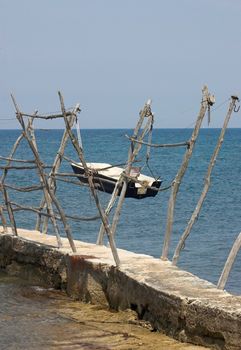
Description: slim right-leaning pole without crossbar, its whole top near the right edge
xmin=172 ymin=96 xmax=238 ymax=265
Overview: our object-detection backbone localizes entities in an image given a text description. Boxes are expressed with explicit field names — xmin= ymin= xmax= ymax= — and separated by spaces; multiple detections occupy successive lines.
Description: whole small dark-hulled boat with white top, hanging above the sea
xmin=71 ymin=163 xmax=162 ymax=199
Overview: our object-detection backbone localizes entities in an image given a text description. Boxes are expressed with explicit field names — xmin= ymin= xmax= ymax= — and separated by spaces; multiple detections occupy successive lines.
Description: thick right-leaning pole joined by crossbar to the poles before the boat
xmin=161 ymin=86 xmax=209 ymax=260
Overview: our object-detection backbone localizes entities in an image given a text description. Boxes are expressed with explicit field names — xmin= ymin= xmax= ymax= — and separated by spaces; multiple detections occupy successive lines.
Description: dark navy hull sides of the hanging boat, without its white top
xmin=71 ymin=164 xmax=161 ymax=199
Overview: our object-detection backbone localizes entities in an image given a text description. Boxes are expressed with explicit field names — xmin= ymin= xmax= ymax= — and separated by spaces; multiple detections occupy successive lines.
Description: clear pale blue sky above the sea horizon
xmin=0 ymin=0 xmax=241 ymax=129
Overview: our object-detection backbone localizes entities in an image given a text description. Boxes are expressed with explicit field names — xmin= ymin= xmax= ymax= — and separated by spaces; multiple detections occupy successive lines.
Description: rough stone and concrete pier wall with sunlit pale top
xmin=0 ymin=229 xmax=241 ymax=350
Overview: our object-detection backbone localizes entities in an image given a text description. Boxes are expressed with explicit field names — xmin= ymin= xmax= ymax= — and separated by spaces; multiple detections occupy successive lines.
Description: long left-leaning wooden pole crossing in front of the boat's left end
xmin=58 ymin=92 xmax=120 ymax=266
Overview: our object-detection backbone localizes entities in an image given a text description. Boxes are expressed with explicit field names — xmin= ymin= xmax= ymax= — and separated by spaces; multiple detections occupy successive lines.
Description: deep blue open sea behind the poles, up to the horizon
xmin=0 ymin=129 xmax=241 ymax=294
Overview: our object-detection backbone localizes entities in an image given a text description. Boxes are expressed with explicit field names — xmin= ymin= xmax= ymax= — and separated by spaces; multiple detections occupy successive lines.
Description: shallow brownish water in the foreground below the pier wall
xmin=0 ymin=272 xmax=207 ymax=350
